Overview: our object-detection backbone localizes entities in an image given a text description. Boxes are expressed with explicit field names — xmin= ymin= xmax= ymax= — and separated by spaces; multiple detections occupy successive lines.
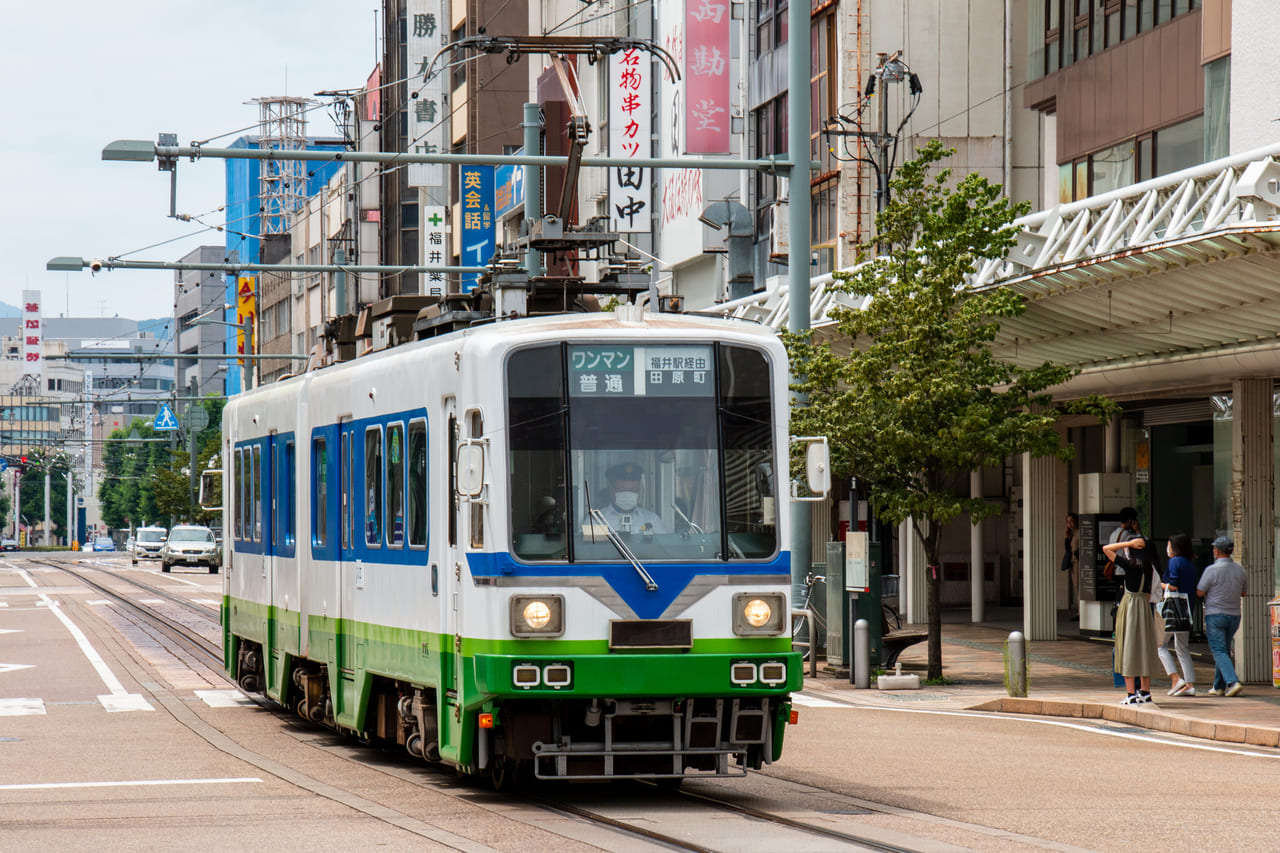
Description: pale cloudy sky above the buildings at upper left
xmin=0 ymin=0 xmax=380 ymax=320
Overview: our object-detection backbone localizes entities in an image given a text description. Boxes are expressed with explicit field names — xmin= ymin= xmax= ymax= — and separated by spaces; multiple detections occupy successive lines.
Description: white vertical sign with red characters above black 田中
xmin=609 ymin=47 xmax=653 ymax=233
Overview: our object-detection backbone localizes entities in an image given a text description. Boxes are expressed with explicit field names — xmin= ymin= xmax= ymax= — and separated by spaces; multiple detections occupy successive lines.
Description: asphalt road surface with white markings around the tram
xmin=0 ymin=550 xmax=1280 ymax=853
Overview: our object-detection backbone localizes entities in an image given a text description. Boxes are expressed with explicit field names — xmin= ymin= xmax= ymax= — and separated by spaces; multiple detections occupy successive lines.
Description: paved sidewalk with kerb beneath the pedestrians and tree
xmin=805 ymin=608 xmax=1280 ymax=747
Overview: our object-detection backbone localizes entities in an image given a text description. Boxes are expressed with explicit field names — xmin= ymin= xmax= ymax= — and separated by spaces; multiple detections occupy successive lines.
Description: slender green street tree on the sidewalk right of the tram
xmin=786 ymin=141 xmax=1115 ymax=679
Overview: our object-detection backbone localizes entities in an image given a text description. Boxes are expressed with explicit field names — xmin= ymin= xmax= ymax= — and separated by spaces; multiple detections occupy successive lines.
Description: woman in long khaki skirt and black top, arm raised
xmin=1102 ymin=535 xmax=1160 ymax=704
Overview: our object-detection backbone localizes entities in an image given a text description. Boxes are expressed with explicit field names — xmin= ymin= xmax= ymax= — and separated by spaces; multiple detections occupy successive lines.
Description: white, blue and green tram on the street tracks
xmin=221 ymin=305 xmax=803 ymax=786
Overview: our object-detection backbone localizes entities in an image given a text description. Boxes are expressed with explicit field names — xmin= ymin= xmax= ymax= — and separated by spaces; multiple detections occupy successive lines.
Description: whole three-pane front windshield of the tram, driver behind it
xmin=507 ymin=345 xmax=777 ymax=562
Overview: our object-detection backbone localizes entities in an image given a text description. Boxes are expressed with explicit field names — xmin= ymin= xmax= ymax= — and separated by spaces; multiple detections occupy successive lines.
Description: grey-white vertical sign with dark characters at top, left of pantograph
xmin=404 ymin=0 xmax=448 ymax=187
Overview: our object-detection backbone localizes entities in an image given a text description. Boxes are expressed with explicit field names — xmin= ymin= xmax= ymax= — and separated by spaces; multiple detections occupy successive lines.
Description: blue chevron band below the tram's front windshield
xmin=467 ymin=551 xmax=791 ymax=619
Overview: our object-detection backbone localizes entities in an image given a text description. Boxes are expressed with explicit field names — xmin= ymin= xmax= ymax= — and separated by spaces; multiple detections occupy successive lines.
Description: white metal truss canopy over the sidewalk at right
xmin=719 ymin=145 xmax=1280 ymax=394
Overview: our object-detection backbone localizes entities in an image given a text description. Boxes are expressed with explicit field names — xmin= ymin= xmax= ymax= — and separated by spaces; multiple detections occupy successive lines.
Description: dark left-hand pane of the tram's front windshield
xmin=507 ymin=345 xmax=570 ymax=560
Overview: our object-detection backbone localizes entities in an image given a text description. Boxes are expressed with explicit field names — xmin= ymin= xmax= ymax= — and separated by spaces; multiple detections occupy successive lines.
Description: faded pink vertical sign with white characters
xmin=685 ymin=0 xmax=732 ymax=154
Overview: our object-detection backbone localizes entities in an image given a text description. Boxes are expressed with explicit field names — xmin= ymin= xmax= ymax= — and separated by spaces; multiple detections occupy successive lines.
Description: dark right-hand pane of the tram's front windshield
xmin=719 ymin=346 xmax=786 ymax=557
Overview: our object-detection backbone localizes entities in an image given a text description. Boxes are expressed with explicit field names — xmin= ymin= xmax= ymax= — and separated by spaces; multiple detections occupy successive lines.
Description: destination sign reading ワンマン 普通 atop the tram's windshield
xmin=568 ymin=345 xmax=716 ymax=397
